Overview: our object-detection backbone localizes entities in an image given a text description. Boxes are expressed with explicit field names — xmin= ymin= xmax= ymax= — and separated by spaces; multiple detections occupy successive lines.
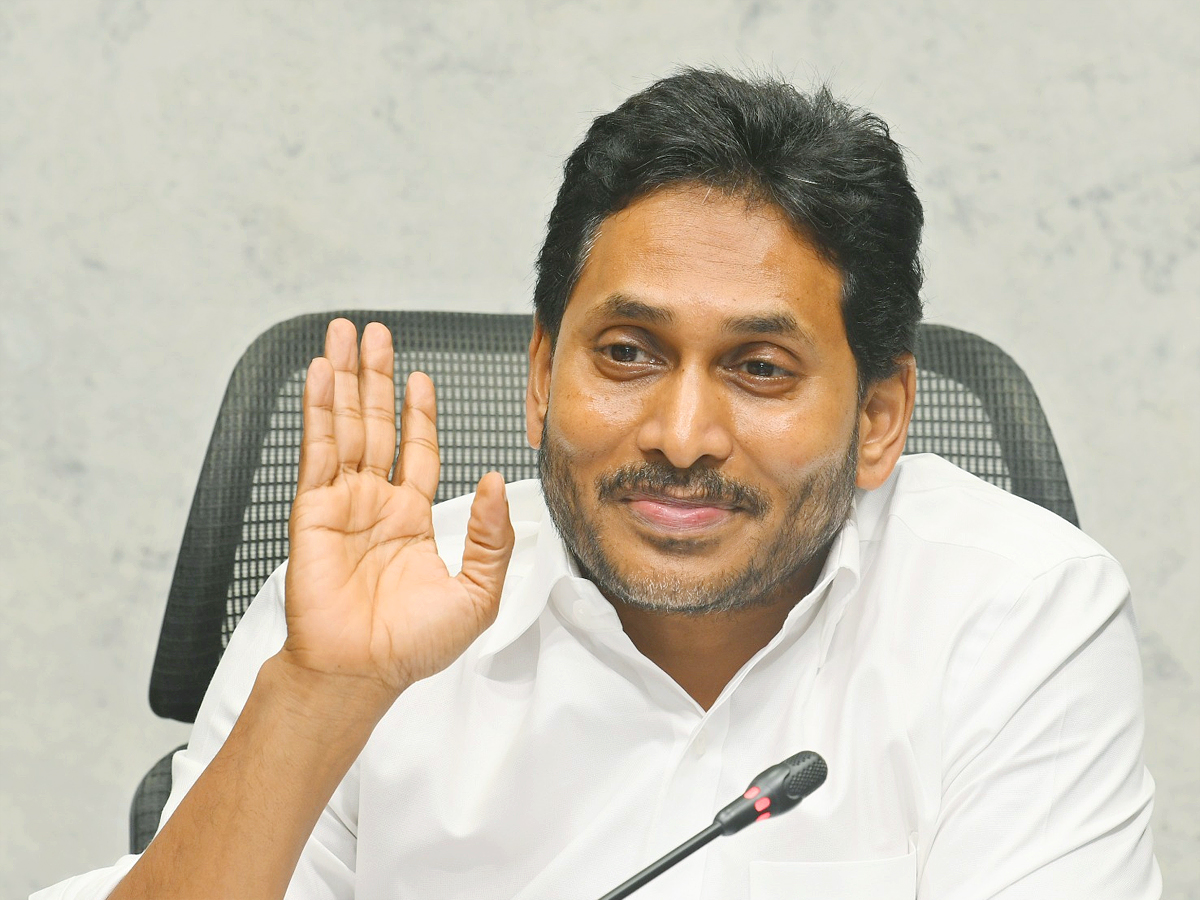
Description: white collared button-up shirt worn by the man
xmin=35 ymin=456 xmax=1162 ymax=900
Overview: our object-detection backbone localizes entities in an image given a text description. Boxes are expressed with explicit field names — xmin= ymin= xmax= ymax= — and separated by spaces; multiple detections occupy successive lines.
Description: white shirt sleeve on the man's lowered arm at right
xmin=918 ymin=556 xmax=1162 ymax=900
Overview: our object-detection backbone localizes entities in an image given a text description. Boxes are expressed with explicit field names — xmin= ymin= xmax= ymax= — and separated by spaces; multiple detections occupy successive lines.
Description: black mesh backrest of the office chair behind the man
xmin=150 ymin=311 xmax=1076 ymax=721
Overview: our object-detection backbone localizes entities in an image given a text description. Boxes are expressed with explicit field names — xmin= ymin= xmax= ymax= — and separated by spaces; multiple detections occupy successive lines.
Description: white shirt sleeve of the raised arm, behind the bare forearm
xmin=30 ymin=563 xmax=358 ymax=900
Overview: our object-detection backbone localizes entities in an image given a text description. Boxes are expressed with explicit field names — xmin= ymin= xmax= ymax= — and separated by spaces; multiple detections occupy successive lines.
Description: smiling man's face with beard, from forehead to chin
xmin=529 ymin=186 xmax=859 ymax=613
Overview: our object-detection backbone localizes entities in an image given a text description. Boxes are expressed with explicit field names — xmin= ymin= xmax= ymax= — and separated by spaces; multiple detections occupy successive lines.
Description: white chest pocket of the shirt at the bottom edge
xmin=750 ymin=853 xmax=917 ymax=900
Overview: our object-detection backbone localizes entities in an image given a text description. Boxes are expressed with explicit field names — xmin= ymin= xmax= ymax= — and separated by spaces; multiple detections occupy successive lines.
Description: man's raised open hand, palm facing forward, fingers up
xmin=280 ymin=319 xmax=514 ymax=703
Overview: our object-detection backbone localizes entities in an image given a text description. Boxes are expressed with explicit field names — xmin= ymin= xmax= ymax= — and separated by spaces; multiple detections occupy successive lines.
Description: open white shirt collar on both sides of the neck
xmin=479 ymin=490 xmax=864 ymax=664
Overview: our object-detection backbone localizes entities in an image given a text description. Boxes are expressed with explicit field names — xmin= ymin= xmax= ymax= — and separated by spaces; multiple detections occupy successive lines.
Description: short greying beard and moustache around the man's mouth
xmin=538 ymin=416 xmax=858 ymax=616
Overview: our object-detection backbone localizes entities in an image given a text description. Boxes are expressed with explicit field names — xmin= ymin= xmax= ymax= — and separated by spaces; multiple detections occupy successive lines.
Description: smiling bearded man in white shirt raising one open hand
xmin=39 ymin=71 xmax=1160 ymax=900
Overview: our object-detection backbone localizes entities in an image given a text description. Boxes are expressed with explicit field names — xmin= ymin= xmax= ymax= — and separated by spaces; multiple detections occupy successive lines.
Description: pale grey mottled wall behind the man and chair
xmin=0 ymin=0 xmax=1200 ymax=898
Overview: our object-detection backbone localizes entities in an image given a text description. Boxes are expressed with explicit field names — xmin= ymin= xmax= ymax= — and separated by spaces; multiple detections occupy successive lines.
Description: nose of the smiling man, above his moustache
xmin=637 ymin=367 xmax=733 ymax=469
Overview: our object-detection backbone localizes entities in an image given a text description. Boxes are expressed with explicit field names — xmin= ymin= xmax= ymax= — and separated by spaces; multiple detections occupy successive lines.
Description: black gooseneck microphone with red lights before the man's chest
xmin=600 ymin=750 xmax=829 ymax=900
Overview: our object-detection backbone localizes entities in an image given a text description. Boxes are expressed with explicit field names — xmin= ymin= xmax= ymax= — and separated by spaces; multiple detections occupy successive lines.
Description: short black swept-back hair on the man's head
xmin=534 ymin=68 xmax=924 ymax=391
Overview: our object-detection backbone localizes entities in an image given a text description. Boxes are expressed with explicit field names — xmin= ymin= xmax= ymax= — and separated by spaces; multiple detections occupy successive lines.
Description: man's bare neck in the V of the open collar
xmin=608 ymin=553 xmax=826 ymax=709
